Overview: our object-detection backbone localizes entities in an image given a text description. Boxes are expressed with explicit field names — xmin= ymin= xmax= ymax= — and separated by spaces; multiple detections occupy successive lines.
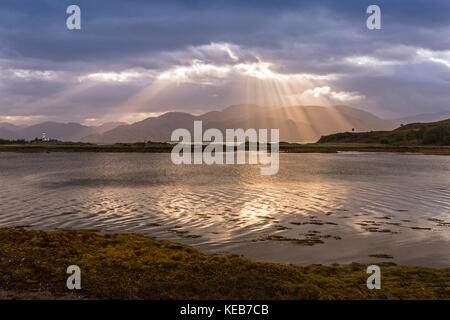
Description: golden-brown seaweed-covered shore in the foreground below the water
xmin=0 ymin=228 xmax=450 ymax=299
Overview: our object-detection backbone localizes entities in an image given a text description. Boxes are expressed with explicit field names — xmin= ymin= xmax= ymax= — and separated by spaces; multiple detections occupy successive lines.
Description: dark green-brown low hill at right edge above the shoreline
xmin=318 ymin=119 xmax=450 ymax=146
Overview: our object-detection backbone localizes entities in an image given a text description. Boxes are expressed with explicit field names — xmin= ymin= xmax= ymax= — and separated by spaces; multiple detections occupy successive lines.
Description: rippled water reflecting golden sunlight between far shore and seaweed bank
xmin=0 ymin=153 xmax=450 ymax=267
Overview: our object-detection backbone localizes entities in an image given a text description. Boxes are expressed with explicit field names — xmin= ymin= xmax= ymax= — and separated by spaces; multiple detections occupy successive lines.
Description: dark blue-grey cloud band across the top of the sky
xmin=0 ymin=0 xmax=450 ymax=66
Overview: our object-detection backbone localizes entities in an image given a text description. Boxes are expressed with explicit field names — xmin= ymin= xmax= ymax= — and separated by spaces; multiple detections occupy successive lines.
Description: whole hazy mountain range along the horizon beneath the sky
xmin=0 ymin=104 xmax=448 ymax=143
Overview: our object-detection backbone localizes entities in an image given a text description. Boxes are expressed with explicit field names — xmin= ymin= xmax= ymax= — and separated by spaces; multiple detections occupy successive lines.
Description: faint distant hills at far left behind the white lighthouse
xmin=0 ymin=122 xmax=124 ymax=141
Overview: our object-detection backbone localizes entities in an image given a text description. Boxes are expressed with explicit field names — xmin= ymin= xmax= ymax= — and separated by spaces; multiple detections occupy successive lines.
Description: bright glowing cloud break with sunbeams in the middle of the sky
xmin=61 ymin=49 xmax=354 ymax=122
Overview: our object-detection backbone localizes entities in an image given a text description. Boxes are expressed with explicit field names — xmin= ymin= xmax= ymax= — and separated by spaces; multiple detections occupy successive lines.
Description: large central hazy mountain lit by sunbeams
xmin=82 ymin=105 xmax=395 ymax=143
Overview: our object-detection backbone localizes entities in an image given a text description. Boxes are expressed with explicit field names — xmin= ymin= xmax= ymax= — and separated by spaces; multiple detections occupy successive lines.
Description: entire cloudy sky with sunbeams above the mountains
xmin=0 ymin=0 xmax=450 ymax=125
